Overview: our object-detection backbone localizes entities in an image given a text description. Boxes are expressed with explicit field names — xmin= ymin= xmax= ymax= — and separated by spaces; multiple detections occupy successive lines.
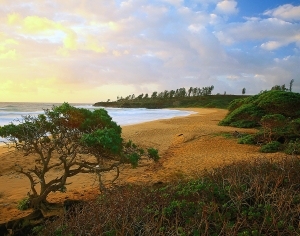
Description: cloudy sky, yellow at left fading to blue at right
xmin=0 ymin=0 xmax=300 ymax=103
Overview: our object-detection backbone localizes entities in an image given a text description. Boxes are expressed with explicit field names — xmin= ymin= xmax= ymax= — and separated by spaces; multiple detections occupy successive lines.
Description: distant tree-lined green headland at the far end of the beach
xmin=94 ymin=85 xmax=246 ymax=109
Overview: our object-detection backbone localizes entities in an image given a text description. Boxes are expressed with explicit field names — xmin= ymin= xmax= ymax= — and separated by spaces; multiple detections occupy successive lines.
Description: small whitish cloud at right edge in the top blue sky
xmin=264 ymin=4 xmax=300 ymax=21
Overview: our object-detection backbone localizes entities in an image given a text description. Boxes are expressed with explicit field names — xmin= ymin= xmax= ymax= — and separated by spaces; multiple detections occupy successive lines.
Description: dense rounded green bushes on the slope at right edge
xmin=219 ymin=86 xmax=300 ymax=153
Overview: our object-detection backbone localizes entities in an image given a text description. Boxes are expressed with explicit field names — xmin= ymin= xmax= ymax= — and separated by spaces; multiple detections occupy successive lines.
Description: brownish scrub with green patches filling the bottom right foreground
xmin=40 ymin=157 xmax=300 ymax=236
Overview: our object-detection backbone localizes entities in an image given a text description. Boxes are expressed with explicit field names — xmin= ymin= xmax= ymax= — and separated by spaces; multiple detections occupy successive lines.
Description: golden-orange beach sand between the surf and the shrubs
xmin=0 ymin=108 xmax=281 ymax=223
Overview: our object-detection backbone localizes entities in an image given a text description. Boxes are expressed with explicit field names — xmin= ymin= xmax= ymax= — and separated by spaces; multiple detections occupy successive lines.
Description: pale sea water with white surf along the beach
xmin=0 ymin=102 xmax=193 ymax=141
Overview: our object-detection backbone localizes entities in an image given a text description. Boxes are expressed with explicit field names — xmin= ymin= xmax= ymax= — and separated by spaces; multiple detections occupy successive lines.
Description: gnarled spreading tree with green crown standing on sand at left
xmin=0 ymin=103 xmax=158 ymax=209
